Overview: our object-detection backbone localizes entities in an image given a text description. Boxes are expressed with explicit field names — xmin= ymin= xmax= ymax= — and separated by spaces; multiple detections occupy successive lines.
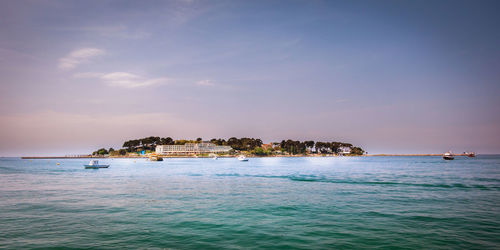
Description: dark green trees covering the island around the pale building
xmin=93 ymin=136 xmax=365 ymax=155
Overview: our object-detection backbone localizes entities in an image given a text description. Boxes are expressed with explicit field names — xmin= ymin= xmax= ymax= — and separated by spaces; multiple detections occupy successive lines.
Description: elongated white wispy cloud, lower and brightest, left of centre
xmin=73 ymin=72 xmax=169 ymax=89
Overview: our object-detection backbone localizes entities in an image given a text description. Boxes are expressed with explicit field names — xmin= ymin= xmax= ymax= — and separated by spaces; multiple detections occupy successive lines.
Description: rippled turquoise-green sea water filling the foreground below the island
xmin=0 ymin=155 xmax=500 ymax=249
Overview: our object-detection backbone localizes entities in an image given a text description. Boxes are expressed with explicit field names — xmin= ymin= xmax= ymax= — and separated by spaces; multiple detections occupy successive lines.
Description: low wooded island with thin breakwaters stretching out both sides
xmin=18 ymin=136 xmax=480 ymax=159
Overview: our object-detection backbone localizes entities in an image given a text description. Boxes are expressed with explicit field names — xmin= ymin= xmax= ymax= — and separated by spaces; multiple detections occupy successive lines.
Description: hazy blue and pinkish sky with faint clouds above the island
xmin=0 ymin=0 xmax=500 ymax=156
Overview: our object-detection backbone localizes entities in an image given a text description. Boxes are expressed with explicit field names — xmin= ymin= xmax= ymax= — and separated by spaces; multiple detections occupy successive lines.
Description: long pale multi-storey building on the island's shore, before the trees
xmin=156 ymin=142 xmax=232 ymax=155
